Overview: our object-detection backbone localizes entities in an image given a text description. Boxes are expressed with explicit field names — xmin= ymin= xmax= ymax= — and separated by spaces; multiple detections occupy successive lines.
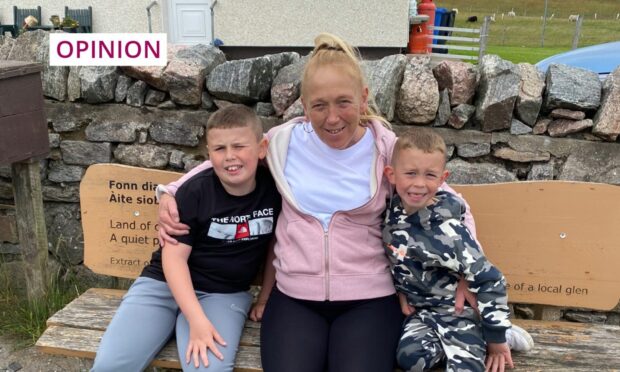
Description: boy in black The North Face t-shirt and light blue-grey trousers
xmin=92 ymin=105 xmax=281 ymax=372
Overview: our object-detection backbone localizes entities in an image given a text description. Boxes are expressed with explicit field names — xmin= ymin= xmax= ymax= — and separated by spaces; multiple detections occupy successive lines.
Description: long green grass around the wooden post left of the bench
xmin=0 ymin=266 xmax=81 ymax=347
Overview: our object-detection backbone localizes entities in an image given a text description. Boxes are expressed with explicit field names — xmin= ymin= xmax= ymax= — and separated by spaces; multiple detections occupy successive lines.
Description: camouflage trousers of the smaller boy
xmin=396 ymin=309 xmax=486 ymax=371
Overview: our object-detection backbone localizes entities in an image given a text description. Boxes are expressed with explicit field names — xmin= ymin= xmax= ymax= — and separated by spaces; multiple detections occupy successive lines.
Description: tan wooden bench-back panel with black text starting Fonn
xmin=80 ymin=164 xmax=182 ymax=278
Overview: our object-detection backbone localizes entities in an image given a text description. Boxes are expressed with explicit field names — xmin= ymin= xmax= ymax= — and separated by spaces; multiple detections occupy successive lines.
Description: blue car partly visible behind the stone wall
xmin=536 ymin=41 xmax=620 ymax=80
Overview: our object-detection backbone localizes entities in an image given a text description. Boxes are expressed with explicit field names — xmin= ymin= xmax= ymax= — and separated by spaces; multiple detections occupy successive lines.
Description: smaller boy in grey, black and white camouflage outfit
xmin=383 ymin=128 xmax=520 ymax=371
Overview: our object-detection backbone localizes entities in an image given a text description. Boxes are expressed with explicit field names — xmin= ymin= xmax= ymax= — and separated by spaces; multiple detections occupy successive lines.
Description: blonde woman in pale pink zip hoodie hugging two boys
xmin=160 ymin=34 xmax=478 ymax=372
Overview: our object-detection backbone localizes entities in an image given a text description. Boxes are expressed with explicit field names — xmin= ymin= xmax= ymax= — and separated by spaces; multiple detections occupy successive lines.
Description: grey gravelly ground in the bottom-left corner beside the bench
xmin=0 ymin=335 xmax=92 ymax=372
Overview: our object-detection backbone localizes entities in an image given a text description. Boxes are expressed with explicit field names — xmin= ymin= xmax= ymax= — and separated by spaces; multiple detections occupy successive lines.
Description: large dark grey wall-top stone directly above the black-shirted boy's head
xmin=207 ymin=57 xmax=273 ymax=103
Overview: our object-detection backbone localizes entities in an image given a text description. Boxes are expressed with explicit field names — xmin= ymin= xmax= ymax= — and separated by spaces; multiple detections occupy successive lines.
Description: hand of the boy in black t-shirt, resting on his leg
xmin=185 ymin=317 xmax=226 ymax=368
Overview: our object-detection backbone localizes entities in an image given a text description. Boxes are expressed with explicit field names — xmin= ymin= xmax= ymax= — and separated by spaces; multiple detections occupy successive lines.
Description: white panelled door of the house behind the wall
xmin=168 ymin=0 xmax=213 ymax=44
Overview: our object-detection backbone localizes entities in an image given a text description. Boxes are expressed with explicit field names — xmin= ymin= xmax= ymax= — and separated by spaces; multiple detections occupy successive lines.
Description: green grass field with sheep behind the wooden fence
xmin=434 ymin=0 xmax=620 ymax=63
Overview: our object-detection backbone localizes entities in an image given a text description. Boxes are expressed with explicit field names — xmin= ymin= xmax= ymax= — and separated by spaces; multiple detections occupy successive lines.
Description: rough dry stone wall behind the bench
xmin=0 ymin=31 xmax=620 ymax=324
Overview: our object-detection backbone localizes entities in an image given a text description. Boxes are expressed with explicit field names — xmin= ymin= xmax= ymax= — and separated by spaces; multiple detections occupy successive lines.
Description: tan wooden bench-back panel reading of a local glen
xmin=454 ymin=181 xmax=620 ymax=310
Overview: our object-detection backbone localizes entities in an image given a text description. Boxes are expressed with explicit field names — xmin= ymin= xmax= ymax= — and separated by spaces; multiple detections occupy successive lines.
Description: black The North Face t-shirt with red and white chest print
xmin=142 ymin=166 xmax=282 ymax=293
